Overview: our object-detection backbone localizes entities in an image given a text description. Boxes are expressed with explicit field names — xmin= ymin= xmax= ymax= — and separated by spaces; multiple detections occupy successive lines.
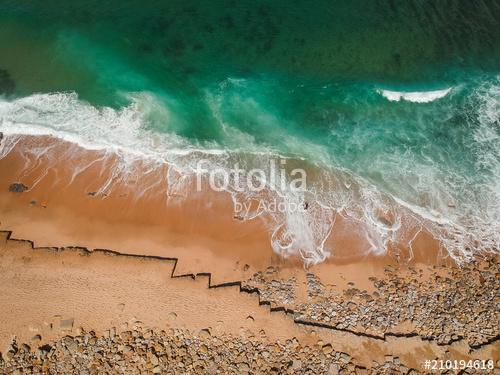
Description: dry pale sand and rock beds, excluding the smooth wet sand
xmin=0 ymin=232 xmax=500 ymax=374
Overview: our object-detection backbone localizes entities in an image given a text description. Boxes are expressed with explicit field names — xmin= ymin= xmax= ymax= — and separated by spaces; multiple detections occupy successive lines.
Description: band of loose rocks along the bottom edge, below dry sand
xmin=0 ymin=328 xmax=428 ymax=375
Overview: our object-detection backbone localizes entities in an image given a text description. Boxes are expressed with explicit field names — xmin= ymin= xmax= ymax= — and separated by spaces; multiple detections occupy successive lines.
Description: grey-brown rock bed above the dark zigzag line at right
xmin=244 ymin=257 xmax=500 ymax=349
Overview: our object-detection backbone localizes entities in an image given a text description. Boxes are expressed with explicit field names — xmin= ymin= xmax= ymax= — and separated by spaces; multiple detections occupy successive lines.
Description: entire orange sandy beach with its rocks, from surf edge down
xmin=0 ymin=137 xmax=500 ymax=374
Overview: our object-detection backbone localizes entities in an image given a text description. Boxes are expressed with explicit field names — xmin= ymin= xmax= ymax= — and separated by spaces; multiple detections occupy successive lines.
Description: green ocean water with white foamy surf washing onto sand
xmin=0 ymin=0 xmax=500 ymax=263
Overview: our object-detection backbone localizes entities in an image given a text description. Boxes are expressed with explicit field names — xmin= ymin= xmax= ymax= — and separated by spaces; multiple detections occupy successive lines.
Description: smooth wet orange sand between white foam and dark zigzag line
xmin=0 ymin=137 xmax=453 ymax=274
